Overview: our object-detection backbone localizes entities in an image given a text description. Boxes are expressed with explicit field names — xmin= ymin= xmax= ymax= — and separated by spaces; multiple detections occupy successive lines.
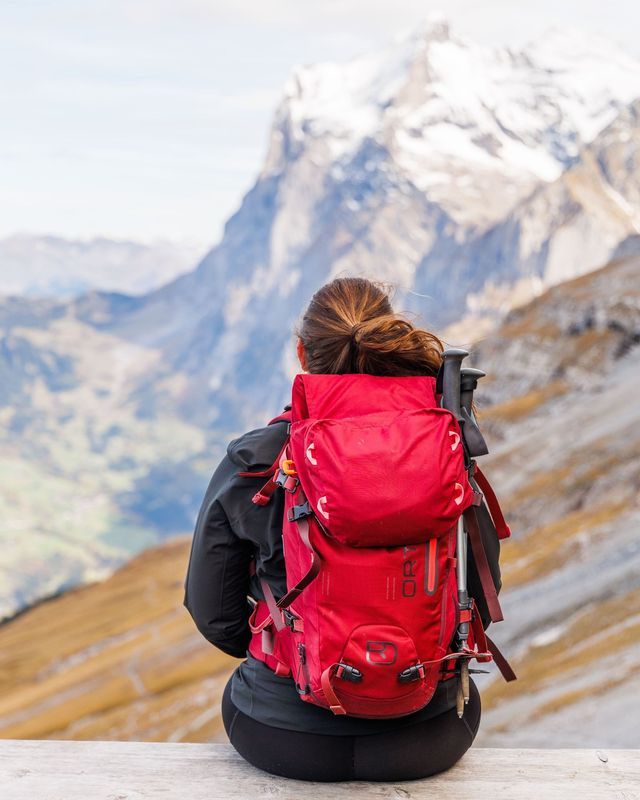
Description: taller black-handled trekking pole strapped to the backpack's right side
xmin=442 ymin=348 xmax=471 ymax=717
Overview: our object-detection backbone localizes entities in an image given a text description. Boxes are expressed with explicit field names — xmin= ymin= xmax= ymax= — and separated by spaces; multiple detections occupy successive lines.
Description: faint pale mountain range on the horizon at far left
xmin=0 ymin=234 xmax=202 ymax=297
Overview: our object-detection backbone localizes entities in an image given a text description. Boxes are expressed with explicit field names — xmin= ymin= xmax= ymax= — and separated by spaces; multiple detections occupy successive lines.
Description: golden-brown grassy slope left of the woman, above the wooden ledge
xmin=0 ymin=540 xmax=233 ymax=741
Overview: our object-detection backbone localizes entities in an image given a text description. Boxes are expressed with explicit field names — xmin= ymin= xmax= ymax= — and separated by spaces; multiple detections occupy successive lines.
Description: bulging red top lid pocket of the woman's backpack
xmin=291 ymin=408 xmax=473 ymax=547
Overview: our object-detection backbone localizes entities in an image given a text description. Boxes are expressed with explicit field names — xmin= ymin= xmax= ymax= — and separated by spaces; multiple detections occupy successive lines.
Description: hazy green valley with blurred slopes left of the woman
xmin=0 ymin=298 xmax=209 ymax=618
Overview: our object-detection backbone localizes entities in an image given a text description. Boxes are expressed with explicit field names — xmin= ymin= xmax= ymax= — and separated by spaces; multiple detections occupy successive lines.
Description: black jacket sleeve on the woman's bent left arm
xmin=184 ymin=456 xmax=253 ymax=658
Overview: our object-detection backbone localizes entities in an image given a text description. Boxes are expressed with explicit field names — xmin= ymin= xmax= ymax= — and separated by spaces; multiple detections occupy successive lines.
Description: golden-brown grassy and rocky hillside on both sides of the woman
xmin=0 ymin=258 xmax=640 ymax=747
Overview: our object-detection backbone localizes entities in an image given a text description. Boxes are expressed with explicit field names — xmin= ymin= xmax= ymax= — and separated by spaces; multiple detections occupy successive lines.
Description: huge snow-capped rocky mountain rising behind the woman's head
xmin=100 ymin=23 xmax=640 ymax=434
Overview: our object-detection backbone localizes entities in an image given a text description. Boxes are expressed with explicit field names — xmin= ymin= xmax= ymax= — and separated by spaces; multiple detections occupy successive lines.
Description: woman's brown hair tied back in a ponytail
xmin=297 ymin=278 xmax=443 ymax=375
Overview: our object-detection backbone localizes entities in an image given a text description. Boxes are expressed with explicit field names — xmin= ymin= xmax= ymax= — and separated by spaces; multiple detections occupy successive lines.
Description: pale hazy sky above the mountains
xmin=0 ymin=0 xmax=640 ymax=244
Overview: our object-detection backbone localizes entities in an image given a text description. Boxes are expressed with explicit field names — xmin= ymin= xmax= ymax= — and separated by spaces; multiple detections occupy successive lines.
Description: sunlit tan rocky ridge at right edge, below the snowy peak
xmin=462 ymin=100 xmax=640 ymax=312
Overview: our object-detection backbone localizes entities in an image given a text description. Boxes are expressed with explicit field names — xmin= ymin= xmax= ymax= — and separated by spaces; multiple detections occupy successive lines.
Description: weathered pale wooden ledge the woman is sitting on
xmin=0 ymin=739 xmax=640 ymax=800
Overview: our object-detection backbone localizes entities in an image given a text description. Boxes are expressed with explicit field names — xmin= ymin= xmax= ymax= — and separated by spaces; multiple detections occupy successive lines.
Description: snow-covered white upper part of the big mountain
xmin=263 ymin=17 xmax=640 ymax=225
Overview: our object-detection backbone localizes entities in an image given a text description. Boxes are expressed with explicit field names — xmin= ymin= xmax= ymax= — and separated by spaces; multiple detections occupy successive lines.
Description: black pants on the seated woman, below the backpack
xmin=222 ymin=682 xmax=480 ymax=781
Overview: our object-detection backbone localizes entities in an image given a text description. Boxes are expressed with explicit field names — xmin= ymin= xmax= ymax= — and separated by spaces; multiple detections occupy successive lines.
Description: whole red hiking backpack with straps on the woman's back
xmin=244 ymin=374 xmax=515 ymax=717
